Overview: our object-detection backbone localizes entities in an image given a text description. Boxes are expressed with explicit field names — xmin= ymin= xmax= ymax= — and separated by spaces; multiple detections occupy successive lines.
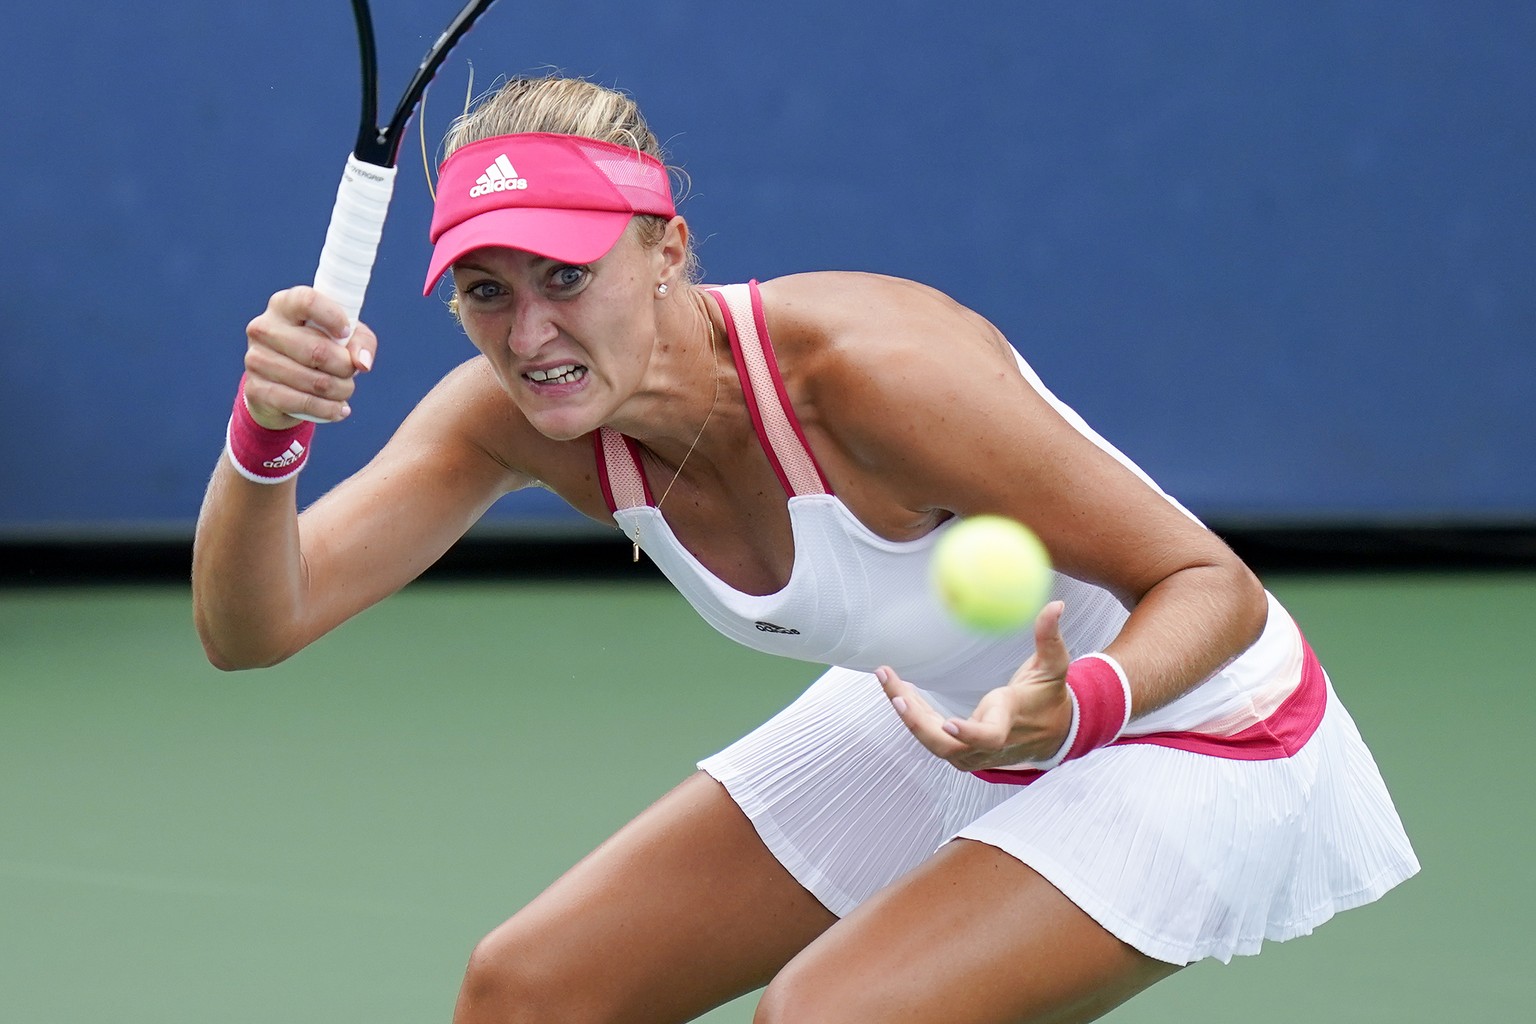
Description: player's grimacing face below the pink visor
xmin=453 ymin=229 xmax=656 ymax=441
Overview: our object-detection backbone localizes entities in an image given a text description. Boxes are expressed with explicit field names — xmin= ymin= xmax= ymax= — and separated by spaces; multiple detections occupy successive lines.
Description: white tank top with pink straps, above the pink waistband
xmin=596 ymin=281 xmax=1327 ymax=752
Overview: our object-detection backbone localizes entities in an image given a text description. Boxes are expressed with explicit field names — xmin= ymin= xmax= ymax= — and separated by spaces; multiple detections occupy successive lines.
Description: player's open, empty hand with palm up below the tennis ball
xmin=876 ymin=600 xmax=1072 ymax=772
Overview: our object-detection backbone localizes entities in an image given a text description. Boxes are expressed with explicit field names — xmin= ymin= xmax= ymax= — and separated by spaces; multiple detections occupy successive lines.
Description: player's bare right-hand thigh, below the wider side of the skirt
xmin=757 ymin=840 xmax=1178 ymax=1024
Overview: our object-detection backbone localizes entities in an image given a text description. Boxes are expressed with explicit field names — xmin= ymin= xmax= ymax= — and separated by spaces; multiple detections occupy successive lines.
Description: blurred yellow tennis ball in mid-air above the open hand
xmin=931 ymin=516 xmax=1051 ymax=633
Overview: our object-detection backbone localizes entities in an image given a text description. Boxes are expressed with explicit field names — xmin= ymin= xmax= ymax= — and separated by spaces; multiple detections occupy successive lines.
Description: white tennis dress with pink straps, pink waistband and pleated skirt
xmin=598 ymin=282 xmax=1418 ymax=964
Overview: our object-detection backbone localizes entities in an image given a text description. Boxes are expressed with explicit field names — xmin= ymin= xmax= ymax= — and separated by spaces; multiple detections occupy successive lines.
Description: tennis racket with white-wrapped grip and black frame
xmin=315 ymin=0 xmax=495 ymax=388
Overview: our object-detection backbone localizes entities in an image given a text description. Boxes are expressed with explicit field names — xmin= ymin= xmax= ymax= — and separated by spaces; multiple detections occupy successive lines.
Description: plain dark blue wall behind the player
xmin=0 ymin=0 xmax=1536 ymax=537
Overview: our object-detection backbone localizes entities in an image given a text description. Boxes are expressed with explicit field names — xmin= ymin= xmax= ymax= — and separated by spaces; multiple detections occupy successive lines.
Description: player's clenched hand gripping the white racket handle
xmin=246 ymin=287 xmax=378 ymax=428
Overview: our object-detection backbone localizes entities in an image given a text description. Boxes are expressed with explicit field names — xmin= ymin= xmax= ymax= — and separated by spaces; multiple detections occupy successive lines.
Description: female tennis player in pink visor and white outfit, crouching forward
xmin=194 ymin=78 xmax=1418 ymax=1024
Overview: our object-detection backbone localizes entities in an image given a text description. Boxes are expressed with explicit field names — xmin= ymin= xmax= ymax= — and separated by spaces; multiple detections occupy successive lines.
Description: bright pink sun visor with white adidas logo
xmin=422 ymin=132 xmax=677 ymax=295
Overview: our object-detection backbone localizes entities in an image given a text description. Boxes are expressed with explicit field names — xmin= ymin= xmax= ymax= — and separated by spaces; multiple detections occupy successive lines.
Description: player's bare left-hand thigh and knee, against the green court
xmin=455 ymin=772 xmax=836 ymax=1024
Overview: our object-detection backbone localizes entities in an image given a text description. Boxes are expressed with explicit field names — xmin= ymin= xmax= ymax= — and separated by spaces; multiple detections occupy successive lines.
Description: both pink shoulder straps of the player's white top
xmin=593 ymin=281 xmax=833 ymax=511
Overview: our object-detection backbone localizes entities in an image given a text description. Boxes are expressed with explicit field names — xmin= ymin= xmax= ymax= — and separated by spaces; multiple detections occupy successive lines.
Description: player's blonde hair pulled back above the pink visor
xmin=442 ymin=75 xmax=700 ymax=284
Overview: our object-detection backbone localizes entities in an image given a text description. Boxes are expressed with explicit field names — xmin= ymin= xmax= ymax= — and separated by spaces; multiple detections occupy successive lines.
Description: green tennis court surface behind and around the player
xmin=0 ymin=574 xmax=1536 ymax=1024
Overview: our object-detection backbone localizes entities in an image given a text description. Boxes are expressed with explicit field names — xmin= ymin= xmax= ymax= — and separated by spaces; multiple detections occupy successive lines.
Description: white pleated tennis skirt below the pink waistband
xmin=699 ymin=668 xmax=1419 ymax=964
